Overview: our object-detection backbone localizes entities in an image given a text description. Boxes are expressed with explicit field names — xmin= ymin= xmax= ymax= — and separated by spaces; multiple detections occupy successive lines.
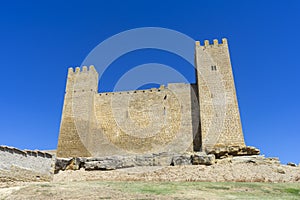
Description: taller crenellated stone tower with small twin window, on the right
xmin=195 ymin=39 xmax=245 ymax=151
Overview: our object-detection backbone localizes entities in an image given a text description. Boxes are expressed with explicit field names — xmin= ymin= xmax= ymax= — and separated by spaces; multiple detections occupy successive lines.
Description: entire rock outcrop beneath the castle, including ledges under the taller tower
xmin=55 ymin=147 xmax=262 ymax=173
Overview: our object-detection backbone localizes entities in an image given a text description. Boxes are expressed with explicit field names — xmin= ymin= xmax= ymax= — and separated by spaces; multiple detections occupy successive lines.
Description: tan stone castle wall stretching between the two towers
xmin=89 ymin=83 xmax=199 ymax=155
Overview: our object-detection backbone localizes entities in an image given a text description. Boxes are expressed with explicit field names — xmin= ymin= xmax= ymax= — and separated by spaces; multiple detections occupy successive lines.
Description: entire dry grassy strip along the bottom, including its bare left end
xmin=0 ymin=181 xmax=300 ymax=200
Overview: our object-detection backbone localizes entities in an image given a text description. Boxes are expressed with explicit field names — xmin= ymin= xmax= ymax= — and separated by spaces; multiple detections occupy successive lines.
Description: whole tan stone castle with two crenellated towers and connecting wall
xmin=57 ymin=39 xmax=245 ymax=157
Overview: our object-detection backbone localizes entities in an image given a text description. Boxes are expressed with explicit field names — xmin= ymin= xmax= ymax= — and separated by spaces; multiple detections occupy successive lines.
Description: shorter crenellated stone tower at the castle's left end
xmin=57 ymin=66 xmax=98 ymax=157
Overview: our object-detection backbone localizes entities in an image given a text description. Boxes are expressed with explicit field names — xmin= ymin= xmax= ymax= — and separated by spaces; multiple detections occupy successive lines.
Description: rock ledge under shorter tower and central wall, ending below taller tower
xmin=55 ymin=152 xmax=215 ymax=173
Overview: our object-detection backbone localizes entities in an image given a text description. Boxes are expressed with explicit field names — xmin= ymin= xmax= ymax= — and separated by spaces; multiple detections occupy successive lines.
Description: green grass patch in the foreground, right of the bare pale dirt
xmin=109 ymin=182 xmax=300 ymax=200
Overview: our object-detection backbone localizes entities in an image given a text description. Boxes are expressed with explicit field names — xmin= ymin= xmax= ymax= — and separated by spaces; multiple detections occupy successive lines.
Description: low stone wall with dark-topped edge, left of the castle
xmin=0 ymin=146 xmax=55 ymax=181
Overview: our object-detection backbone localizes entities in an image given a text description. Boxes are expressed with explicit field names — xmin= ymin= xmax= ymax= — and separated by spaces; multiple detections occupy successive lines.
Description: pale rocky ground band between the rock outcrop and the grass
xmin=53 ymin=159 xmax=300 ymax=183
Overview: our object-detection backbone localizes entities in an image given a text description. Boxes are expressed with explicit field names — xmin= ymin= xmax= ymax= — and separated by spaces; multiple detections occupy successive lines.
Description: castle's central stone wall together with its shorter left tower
xmin=57 ymin=67 xmax=200 ymax=157
